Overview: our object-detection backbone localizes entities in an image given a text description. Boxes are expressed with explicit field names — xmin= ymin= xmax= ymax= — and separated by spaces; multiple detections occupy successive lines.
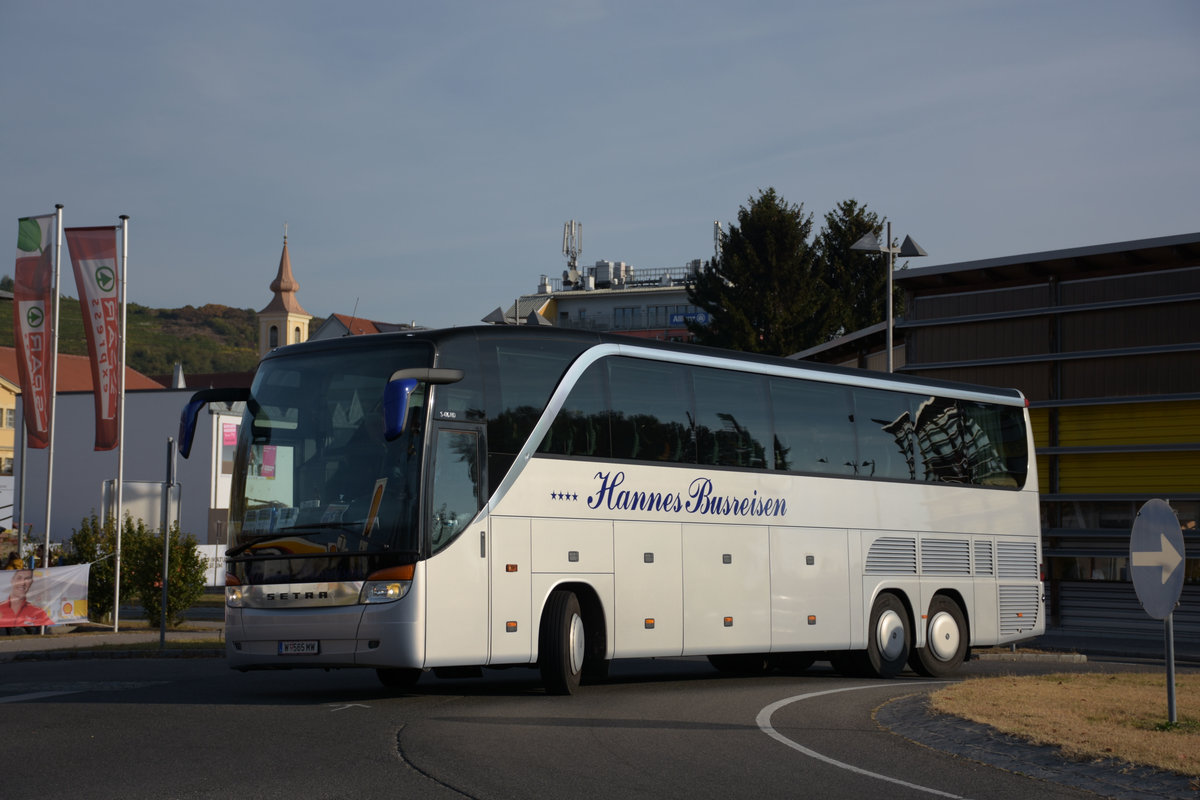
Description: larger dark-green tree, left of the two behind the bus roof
xmin=688 ymin=188 xmax=834 ymax=355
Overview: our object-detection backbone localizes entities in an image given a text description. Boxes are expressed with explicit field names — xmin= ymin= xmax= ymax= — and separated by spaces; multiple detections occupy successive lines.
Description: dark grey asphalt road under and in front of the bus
xmin=0 ymin=658 xmax=1185 ymax=800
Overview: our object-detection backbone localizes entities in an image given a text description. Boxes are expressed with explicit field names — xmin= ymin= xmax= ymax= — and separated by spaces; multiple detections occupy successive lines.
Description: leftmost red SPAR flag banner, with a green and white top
xmin=12 ymin=215 xmax=56 ymax=449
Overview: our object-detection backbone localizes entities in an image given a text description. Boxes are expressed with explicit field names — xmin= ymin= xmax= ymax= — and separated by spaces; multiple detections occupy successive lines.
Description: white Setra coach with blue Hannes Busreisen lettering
xmin=180 ymin=326 xmax=1045 ymax=693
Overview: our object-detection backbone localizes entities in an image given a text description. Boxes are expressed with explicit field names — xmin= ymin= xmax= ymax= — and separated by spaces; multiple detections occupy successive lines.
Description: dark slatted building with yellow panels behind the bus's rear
xmin=892 ymin=233 xmax=1200 ymax=642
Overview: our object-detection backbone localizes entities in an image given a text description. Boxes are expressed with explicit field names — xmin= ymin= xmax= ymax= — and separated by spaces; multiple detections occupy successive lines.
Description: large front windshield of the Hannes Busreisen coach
xmin=228 ymin=342 xmax=433 ymax=584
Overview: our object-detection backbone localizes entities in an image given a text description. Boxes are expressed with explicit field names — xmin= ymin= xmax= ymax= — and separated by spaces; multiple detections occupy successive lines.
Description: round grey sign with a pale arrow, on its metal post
xmin=1129 ymin=499 xmax=1184 ymax=722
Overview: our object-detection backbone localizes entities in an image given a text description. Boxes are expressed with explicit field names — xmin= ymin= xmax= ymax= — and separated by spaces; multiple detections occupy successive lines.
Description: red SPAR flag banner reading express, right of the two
xmin=65 ymin=225 xmax=122 ymax=450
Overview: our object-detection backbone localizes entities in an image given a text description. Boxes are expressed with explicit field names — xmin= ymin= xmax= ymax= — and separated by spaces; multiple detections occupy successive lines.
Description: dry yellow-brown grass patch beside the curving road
xmin=931 ymin=673 xmax=1200 ymax=778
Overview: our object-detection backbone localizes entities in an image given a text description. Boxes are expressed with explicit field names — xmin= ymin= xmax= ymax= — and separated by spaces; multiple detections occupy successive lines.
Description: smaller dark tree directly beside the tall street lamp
xmin=815 ymin=199 xmax=901 ymax=333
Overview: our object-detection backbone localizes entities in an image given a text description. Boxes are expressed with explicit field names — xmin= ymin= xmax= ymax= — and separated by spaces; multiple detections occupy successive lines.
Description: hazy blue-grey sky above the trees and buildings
xmin=0 ymin=0 xmax=1200 ymax=326
